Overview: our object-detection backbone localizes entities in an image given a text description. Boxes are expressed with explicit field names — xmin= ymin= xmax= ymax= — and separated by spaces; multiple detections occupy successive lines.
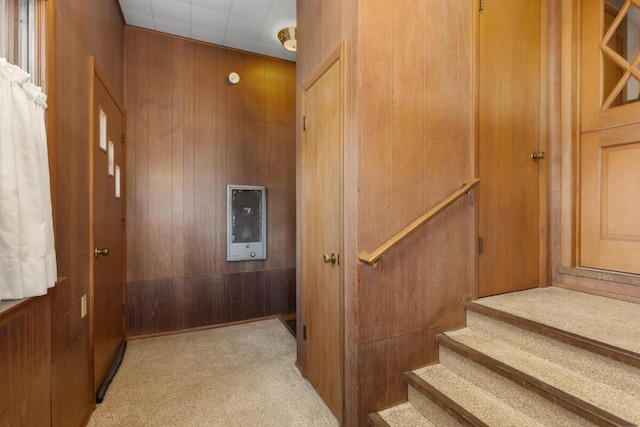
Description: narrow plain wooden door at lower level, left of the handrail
xmin=300 ymin=46 xmax=344 ymax=420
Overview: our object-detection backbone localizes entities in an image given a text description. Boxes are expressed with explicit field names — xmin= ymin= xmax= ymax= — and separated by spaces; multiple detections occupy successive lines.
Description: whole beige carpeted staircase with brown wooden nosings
xmin=369 ymin=287 xmax=640 ymax=427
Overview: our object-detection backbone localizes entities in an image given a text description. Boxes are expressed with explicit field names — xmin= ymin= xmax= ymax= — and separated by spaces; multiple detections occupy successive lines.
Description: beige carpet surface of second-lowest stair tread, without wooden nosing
xmin=413 ymin=364 xmax=542 ymax=427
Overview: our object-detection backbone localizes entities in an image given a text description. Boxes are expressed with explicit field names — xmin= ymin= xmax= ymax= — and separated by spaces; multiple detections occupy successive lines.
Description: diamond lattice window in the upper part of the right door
xmin=602 ymin=0 xmax=640 ymax=107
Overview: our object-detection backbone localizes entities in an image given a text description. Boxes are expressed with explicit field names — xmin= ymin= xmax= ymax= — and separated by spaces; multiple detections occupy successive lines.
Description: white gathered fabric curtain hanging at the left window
xmin=0 ymin=58 xmax=57 ymax=301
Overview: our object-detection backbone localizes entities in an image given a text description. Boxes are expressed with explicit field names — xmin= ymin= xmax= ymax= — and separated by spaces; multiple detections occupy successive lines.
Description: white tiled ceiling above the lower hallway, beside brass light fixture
xmin=119 ymin=0 xmax=296 ymax=61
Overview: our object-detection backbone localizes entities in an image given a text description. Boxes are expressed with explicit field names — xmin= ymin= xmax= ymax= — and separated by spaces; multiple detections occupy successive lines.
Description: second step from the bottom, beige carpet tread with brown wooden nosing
xmin=406 ymin=364 xmax=544 ymax=427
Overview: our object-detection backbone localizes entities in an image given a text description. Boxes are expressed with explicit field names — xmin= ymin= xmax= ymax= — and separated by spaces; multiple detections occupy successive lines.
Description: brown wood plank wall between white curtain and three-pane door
xmin=49 ymin=0 xmax=124 ymax=426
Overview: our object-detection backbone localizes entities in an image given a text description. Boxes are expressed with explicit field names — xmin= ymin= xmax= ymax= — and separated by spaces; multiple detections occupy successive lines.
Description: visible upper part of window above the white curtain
xmin=0 ymin=0 xmax=45 ymax=86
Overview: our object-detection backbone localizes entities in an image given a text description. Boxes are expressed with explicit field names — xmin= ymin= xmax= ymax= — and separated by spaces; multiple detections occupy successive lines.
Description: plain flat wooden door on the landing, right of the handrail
xmin=478 ymin=0 xmax=545 ymax=296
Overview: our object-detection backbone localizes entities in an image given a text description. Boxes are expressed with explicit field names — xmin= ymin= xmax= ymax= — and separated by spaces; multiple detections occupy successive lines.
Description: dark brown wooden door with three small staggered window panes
xmin=90 ymin=61 xmax=125 ymax=402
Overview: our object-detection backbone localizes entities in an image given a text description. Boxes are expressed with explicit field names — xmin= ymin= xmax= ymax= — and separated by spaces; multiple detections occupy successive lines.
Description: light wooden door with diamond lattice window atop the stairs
xmin=578 ymin=0 xmax=640 ymax=274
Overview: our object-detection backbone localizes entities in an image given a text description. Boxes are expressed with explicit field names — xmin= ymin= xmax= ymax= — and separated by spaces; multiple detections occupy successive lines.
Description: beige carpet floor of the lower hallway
xmin=88 ymin=319 xmax=338 ymax=427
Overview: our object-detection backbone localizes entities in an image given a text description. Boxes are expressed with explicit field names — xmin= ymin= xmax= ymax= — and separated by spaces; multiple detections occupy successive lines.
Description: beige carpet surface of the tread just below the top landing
xmin=446 ymin=328 xmax=640 ymax=423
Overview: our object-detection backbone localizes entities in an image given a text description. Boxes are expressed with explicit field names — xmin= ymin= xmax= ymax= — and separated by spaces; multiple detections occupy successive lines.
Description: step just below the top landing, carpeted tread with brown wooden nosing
xmin=438 ymin=327 xmax=640 ymax=425
